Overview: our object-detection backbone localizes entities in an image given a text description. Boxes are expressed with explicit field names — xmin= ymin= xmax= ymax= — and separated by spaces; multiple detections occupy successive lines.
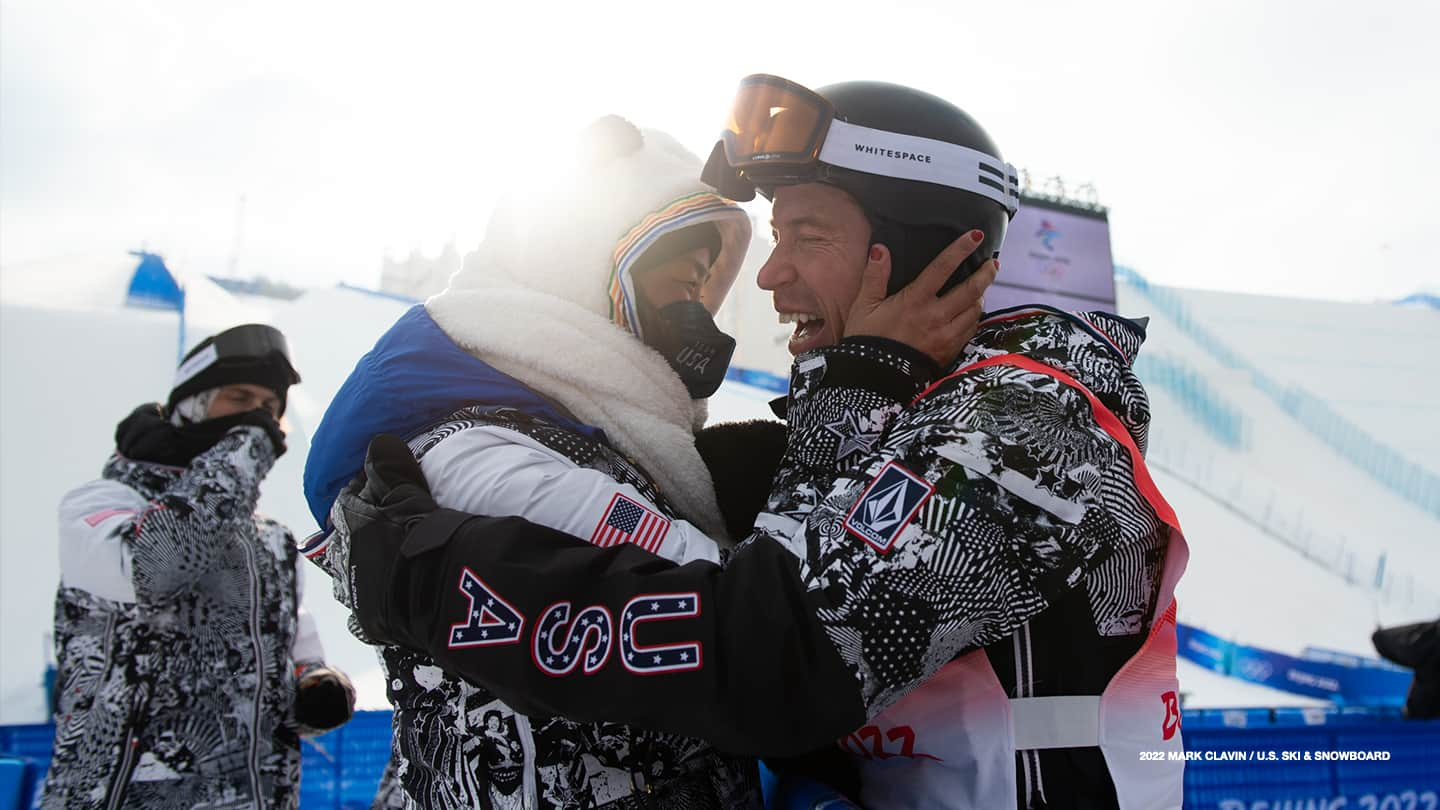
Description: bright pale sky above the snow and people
xmin=0 ymin=0 xmax=1440 ymax=300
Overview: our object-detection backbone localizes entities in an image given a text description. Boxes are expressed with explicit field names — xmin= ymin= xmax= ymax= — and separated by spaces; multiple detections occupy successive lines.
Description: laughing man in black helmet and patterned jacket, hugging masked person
xmin=336 ymin=76 xmax=1188 ymax=810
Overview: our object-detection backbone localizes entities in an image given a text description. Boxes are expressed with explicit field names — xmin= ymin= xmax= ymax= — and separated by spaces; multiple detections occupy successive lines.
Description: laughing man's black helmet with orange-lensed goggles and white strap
xmin=703 ymin=74 xmax=1020 ymax=294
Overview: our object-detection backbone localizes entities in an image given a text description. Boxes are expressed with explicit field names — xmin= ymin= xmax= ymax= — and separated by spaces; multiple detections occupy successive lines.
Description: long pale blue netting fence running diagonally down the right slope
xmin=1115 ymin=267 xmax=1440 ymax=517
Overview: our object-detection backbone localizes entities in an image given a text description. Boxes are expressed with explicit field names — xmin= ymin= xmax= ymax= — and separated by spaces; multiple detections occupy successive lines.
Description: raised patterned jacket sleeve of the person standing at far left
xmin=121 ymin=427 xmax=275 ymax=604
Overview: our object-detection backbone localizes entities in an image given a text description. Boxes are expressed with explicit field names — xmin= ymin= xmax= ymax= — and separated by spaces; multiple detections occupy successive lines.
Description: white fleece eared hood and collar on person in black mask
xmin=425 ymin=117 xmax=750 ymax=543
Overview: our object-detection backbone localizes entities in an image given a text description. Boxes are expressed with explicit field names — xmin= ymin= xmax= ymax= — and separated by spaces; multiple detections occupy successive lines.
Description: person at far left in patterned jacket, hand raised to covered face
xmin=43 ymin=324 xmax=354 ymax=810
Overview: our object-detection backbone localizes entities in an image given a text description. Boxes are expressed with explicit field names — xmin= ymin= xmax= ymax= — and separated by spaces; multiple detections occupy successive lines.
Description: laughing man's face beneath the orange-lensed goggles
xmin=756 ymin=183 xmax=870 ymax=355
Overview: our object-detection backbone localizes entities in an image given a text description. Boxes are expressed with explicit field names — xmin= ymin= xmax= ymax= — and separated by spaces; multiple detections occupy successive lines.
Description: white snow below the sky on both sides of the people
xmin=0 ymin=257 xmax=1440 ymax=724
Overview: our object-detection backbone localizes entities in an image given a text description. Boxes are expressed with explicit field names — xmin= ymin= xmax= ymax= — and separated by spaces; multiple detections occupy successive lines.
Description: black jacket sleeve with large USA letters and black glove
xmin=333 ymin=489 xmax=864 ymax=755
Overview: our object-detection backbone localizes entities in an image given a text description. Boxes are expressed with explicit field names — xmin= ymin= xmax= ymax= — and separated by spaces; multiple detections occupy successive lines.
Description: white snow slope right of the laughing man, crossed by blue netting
xmin=1119 ymin=276 xmax=1440 ymax=625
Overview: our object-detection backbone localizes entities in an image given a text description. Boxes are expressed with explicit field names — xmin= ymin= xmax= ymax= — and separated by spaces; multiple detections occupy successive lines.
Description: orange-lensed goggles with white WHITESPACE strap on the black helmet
xmin=703 ymin=74 xmax=1020 ymax=216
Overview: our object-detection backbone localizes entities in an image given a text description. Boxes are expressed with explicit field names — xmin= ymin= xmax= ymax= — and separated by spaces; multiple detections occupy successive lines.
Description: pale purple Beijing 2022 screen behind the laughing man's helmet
xmin=985 ymin=197 xmax=1115 ymax=313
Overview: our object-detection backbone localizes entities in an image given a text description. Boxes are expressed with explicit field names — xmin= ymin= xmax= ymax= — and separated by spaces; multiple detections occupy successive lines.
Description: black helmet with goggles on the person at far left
xmin=166 ymin=323 xmax=300 ymax=414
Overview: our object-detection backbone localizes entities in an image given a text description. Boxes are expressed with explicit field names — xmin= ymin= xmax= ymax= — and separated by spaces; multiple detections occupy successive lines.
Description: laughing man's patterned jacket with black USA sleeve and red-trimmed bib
xmin=336 ymin=307 xmax=1188 ymax=809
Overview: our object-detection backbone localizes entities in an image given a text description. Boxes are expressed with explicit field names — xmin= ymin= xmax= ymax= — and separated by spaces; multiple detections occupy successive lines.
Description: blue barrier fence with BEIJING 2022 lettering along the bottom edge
xmin=0 ymin=706 xmax=1440 ymax=810
